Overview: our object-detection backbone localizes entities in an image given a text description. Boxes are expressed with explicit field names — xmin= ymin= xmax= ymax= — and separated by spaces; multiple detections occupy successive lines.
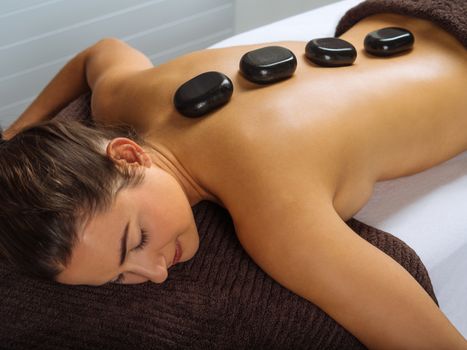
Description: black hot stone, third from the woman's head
xmin=305 ymin=38 xmax=357 ymax=67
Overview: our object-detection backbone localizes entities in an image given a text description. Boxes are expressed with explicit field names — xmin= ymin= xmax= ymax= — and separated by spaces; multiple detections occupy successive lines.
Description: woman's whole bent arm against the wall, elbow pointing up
xmin=3 ymin=38 xmax=152 ymax=140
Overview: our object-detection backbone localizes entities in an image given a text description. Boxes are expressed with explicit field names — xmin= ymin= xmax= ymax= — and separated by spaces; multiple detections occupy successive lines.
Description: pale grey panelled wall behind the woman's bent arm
xmin=0 ymin=0 xmax=234 ymax=127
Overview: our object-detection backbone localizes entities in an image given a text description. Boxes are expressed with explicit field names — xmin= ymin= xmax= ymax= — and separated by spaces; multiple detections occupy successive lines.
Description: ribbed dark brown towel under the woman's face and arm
xmin=0 ymin=191 xmax=437 ymax=350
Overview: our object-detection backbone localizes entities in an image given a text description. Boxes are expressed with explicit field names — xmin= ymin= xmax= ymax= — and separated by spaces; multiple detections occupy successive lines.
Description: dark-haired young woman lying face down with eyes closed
xmin=0 ymin=0 xmax=467 ymax=349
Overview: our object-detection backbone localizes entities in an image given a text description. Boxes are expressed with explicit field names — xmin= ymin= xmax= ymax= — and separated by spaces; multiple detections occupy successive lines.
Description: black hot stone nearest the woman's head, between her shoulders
xmin=174 ymin=72 xmax=233 ymax=118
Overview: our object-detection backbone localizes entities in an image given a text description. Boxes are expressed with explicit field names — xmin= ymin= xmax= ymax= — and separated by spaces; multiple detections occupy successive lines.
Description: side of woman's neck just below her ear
xmin=146 ymin=143 xmax=218 ymax=206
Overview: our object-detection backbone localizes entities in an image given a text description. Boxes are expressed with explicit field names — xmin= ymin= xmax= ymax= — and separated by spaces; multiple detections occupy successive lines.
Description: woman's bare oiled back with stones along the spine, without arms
xmin=93 ymin=14 xmax=467 ymax=221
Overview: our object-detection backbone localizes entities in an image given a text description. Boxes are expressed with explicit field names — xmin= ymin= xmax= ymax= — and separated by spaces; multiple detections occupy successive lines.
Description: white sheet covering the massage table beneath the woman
xmin=211 ymin=0 xmax=467 ymax=338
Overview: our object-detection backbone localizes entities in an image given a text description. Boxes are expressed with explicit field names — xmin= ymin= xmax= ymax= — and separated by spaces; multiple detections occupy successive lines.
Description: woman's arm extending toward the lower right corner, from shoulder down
xmin=237 ymin=200 xmax=467 ymax=350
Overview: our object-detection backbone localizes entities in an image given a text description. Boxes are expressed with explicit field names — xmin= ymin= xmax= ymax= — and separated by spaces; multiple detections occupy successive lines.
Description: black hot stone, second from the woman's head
xmin=240 ymin=46 xmax=297 ymax=84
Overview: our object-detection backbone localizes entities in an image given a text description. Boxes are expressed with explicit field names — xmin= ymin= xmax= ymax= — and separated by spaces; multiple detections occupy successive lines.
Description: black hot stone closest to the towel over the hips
xmin=364 ymin=27 xmax=415 ymax=56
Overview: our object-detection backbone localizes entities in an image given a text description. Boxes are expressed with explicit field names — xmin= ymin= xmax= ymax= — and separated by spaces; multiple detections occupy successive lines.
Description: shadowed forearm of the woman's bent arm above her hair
xmin=3 ymin=50 xmax=89 ymax=140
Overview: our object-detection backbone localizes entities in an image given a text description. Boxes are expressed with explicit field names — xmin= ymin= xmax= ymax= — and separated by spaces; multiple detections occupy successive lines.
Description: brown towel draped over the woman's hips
xmin=335 ymin=0 xmax=467 ymax=48
